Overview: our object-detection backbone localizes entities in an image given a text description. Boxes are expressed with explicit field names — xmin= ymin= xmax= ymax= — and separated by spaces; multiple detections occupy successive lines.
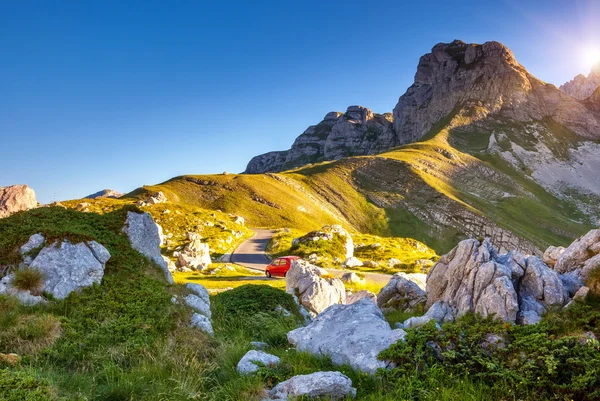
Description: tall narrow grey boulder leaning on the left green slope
xmin=123 ymin=212 xmax=175 ymax=284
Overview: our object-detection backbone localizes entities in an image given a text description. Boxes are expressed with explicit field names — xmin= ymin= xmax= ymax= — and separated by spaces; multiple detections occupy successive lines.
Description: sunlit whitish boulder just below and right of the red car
xmin=285 ymin=259 xmax=346 ymax=316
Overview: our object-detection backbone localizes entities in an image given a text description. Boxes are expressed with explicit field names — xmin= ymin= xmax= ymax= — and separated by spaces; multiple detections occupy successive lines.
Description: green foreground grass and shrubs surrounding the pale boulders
xmin=0 ymin=206 xmax=600 ymax=401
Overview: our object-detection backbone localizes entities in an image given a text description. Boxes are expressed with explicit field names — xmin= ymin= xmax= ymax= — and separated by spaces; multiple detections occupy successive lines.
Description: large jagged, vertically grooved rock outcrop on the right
xmin=427 ymin=239 xmax=577 ymax=323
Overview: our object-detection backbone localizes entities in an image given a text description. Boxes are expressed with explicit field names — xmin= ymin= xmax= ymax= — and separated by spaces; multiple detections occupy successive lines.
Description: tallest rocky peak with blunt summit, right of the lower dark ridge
xmin=394 ymin=41 xmax=600 ymax=143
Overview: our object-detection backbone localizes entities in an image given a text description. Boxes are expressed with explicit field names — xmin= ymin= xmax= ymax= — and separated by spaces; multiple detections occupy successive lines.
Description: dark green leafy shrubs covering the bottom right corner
xmin=380 ymin=306 xmax=600 ymax=400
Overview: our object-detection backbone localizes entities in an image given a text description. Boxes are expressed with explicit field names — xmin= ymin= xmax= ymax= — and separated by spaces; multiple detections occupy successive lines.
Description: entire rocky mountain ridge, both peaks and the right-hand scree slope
xmin=246 ymin=40 xmax=600 ymax=228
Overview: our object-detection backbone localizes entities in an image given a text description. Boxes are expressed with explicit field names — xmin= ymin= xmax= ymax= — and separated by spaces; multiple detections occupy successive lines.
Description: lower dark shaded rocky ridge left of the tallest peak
xmin=245 ymin=106 xmax=396 ymax=174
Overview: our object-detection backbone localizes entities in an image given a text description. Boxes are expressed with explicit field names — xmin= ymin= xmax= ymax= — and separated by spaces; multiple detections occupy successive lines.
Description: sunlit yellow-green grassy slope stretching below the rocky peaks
xmin=128 ymin=134 xmax=591 ymax=254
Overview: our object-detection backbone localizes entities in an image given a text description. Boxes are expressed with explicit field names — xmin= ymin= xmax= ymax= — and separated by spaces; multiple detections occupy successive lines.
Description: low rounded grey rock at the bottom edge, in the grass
xmin=269 ymin=372 xmax=356 ymax=400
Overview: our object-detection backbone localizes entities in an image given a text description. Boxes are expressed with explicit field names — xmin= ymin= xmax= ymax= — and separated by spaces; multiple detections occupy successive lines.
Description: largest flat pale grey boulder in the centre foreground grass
xmin=287 ymin=298 xmax=406 ymax=374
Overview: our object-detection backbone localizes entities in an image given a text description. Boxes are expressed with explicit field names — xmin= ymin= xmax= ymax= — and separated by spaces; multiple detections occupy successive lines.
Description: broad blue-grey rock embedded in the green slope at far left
xmin=30 ymin=239 xmax=110 ymax=299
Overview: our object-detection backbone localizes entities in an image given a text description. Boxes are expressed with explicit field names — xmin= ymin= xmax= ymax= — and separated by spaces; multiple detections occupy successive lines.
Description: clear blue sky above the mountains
xmin=0 ymin=0 xmax=600 ymax=202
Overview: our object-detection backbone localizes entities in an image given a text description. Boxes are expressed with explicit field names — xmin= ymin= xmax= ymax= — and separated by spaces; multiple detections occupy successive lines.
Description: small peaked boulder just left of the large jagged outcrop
xmin=377 ymin=273 xmax=427 ymax=312
